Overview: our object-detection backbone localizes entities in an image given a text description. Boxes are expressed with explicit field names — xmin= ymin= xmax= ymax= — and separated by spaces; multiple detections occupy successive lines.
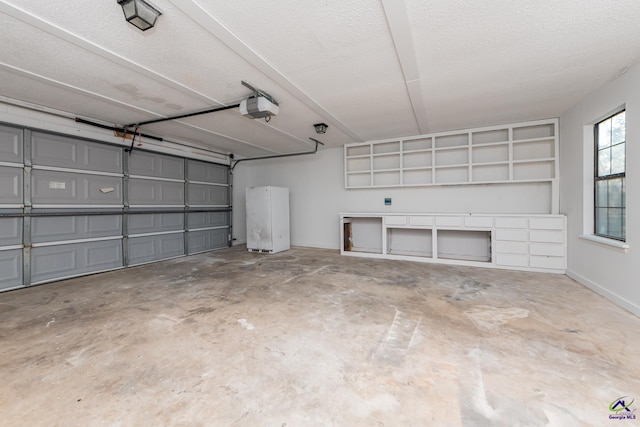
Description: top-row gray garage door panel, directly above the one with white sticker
xmin=31 ymin=132 xmax=122 ymax=173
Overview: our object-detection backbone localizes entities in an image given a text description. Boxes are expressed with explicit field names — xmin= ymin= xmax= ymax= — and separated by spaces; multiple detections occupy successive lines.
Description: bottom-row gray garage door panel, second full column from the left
xmin=128 ymin=233 xmax=184 ymax=265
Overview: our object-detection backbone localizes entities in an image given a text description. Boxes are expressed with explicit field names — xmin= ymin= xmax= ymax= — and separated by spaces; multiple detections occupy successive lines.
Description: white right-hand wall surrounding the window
xmin=560 ymin=66 xmax=640 ymax=315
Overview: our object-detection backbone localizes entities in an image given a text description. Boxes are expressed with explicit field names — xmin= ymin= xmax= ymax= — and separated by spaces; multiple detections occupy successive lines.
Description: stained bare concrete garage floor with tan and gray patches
xmin=0 ymin=247 xmax=640 ymax=427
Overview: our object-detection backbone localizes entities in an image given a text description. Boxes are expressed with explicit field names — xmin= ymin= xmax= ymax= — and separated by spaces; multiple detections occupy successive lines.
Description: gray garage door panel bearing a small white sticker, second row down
xmin=31 ymin=170 xmax=122 ymax=206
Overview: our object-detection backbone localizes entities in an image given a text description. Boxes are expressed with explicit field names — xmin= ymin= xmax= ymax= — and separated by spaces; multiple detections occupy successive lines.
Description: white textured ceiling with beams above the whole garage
xmin=0 ymin=0 xmax=640 ymax=156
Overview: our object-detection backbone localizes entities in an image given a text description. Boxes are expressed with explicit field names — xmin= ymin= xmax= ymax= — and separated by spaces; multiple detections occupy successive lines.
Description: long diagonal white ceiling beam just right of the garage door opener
xmin=169 ymin=0 xmax=363 ymax=141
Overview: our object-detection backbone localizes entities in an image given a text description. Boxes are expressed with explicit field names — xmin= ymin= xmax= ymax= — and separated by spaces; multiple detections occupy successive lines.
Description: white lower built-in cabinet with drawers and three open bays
xmin=340 ymin=213 xmax=566 ymax=273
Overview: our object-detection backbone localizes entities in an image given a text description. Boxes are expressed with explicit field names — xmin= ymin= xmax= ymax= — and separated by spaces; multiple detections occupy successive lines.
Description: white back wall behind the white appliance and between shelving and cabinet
xmin=233 ymin=148 xmax=551 ymax=249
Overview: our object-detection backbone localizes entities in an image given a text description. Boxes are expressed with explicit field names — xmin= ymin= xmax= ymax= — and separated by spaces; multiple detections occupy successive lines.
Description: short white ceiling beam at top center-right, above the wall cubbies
xmin=382 ymin=0 xmax=429 ymax=133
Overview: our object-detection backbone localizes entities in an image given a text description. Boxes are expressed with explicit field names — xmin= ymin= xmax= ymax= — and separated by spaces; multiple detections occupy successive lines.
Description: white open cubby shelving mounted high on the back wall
xmin=344 ymin=119 xmax=558 ymax=188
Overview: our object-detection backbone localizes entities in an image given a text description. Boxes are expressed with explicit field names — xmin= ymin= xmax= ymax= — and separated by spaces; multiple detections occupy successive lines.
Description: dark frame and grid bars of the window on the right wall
xmin=592 ymin=108 xmax=627 ymax=243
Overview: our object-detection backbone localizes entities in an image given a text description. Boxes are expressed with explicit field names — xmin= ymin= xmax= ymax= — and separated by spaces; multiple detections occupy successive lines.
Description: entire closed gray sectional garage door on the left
xmin=0 ymin=125 xmax=231 ymax=290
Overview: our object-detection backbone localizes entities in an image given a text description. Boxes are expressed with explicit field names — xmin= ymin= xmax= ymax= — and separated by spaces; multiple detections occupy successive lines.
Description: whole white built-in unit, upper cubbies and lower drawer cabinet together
xmin=340 ymin=119 xmax=566 ymax=273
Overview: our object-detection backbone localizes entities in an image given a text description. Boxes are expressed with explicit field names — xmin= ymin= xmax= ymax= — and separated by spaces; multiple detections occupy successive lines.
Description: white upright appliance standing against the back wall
xmin=246 ymin=187 xmax=290 ymax=253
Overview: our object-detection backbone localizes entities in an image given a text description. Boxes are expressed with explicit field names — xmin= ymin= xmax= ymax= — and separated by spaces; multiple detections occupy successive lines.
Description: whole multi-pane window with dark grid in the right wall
xmin=594 ymin=111 xmax=626 ymax=241
